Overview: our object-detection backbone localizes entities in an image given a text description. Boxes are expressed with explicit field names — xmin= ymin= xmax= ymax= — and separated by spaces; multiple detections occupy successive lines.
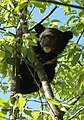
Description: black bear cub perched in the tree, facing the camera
xmin=16 ymin=24 xmax=73 ymax=94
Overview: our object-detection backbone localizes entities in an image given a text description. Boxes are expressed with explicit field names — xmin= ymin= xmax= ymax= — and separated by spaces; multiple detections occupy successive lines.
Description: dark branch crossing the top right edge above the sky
xmin=39 ymin=0 xmax=84 ymax=10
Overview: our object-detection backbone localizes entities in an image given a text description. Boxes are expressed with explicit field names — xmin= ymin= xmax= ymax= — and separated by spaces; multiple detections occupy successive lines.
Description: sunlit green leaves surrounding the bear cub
xmin=0 ymin=0 xmax=84 ymax=120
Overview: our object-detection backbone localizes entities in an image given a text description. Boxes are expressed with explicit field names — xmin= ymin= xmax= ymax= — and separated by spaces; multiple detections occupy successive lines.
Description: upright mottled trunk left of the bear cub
xmin=10 ymin=6 xmax=28 ymax=120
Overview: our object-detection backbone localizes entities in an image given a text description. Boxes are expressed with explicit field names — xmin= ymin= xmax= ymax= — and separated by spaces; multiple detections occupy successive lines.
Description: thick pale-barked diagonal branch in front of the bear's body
xmin=35 ymin=58 xmax=63 ymax=120
